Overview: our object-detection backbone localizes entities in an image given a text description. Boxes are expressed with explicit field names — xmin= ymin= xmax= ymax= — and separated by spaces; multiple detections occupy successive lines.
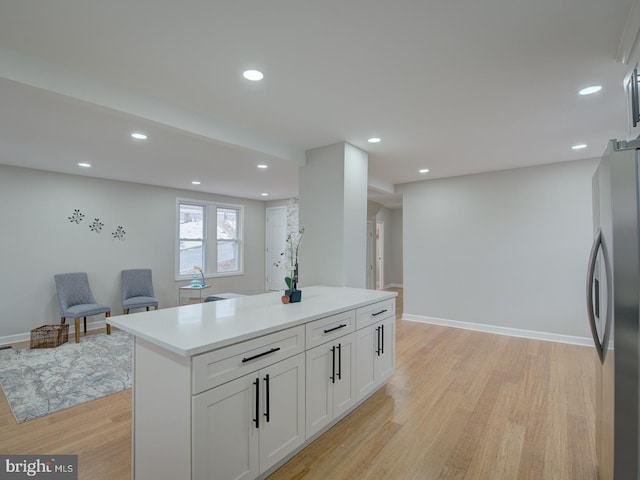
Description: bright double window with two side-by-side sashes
xmin=176 ymin=200 xmax=243 ymax=279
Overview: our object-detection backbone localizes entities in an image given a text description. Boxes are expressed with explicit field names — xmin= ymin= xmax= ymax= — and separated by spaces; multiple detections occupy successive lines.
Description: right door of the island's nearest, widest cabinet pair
xmin=259 ymin=353 xmax=305 ymax=472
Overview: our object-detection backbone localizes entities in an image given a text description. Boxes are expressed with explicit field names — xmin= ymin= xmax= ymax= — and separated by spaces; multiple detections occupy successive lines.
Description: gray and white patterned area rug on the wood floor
xmin=0 ymin=331 xmax=133 ymax=423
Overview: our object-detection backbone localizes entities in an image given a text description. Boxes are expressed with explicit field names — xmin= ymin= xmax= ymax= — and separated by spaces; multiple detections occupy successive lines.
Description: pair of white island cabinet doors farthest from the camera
xmin=356 ymin=317 xmax=396 ymax=401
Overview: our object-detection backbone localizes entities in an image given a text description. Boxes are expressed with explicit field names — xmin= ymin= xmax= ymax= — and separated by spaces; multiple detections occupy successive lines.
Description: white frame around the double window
xmin=174 ymin=198 xmax=244 ymax=280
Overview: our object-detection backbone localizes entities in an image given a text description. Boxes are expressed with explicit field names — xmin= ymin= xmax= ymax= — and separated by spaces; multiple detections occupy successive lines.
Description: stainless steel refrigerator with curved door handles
xmin=587 ymin=140 xmax=640 ymax=480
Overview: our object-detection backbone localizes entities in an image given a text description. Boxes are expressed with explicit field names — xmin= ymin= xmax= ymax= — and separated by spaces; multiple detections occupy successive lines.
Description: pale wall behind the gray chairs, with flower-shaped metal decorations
xmin=0 ymin=166 xmax=265 ymax=344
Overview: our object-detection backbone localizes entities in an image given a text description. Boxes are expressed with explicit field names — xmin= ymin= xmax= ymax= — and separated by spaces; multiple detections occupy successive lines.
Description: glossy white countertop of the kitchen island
xmin=107 ymin=287 xmax=397 ymax=357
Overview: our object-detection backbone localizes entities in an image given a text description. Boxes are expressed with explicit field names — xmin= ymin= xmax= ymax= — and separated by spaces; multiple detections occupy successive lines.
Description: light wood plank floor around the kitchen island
xmin=0 ymin=286 xmax=597 ymax=480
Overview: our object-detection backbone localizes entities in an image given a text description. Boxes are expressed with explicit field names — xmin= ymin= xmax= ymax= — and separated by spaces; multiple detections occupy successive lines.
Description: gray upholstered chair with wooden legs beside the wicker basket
xmin=53 ymin=272 xmax=111 ymax=343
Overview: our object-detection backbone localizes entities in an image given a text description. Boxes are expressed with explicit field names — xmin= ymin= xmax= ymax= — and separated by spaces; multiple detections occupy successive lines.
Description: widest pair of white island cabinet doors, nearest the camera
xmin=193 ymin=354 xmax=305 ymax=480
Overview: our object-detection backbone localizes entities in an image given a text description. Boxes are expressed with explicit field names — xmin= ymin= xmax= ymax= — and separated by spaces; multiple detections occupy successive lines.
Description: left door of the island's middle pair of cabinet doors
xmin=306 ymin=343 xmax=333 ymax=438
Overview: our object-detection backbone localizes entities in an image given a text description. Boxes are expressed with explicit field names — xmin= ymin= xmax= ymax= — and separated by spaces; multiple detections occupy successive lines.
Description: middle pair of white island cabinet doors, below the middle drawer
xmin=306 ymin=333 xmax=356 ymax=438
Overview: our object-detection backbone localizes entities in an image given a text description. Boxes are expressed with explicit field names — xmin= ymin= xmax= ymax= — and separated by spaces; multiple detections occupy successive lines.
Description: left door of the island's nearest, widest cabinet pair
xmin=193 ymin=373 xmax=262 ymax=480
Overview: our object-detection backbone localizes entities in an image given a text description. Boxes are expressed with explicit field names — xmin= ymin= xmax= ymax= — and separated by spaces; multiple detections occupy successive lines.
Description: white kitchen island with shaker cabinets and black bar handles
xmin=109 ymin=287 xmax=396 ymax=480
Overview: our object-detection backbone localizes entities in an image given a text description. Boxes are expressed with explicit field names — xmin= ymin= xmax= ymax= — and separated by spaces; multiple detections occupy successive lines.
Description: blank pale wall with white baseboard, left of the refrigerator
xmin=402 ymin=160 xmax=597 ymax=337
